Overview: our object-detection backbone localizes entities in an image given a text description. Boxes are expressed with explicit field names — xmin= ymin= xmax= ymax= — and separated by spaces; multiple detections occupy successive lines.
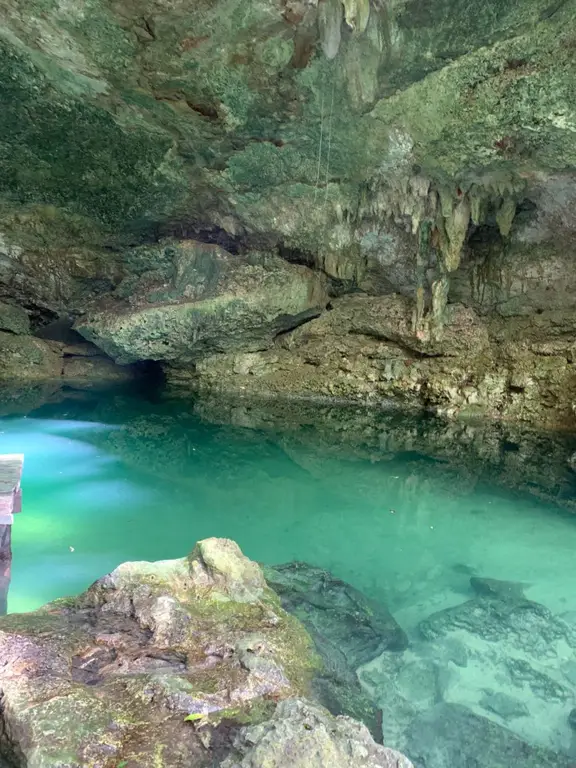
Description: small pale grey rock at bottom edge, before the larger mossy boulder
xmin=221 ymin=699 xmax=413 ymax=768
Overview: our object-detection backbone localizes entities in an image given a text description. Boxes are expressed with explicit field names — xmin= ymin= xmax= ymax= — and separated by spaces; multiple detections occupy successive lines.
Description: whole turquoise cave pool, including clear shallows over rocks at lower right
xmin=0 ymin=393 xmax=576 ymax=768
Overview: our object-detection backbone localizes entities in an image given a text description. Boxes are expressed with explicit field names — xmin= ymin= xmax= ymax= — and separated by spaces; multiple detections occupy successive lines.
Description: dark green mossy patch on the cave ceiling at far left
xmin=0 ymin=39 xmax=187 ymax=227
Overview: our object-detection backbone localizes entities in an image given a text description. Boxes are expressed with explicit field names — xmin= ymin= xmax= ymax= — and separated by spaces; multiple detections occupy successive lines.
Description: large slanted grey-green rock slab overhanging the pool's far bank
xmin=76 ymin=242 xmax=328 ymax=366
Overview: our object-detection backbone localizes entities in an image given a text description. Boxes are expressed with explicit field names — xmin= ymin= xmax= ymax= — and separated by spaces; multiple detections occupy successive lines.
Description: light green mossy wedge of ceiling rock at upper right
xmin=374 ymin=10 xmax=576 ymax=183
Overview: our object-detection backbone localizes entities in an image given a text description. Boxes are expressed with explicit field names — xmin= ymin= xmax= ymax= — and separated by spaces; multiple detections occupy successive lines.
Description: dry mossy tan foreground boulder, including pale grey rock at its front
xmin=0 ymin=539 xmax=412 ymax=768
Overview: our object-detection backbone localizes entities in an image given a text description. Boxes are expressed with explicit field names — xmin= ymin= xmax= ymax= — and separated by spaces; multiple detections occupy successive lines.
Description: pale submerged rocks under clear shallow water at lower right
xmin=359 ymin=577 xmax=576 ymax=768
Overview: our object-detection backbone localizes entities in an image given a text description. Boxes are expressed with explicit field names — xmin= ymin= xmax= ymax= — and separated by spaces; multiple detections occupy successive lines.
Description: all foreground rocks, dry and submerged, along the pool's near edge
xmin=0 ymin=539 xmax=576 ymax=768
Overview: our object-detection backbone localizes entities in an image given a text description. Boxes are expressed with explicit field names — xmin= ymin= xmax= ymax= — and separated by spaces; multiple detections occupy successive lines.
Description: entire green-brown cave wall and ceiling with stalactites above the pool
xmin=0 ymin=0 xmax=576 ymax=427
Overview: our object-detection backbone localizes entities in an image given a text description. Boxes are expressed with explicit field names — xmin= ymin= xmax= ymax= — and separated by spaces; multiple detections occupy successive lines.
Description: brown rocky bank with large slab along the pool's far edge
xmin=0 ymin=234 xmax=576 ymax=430
